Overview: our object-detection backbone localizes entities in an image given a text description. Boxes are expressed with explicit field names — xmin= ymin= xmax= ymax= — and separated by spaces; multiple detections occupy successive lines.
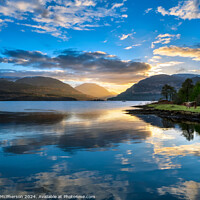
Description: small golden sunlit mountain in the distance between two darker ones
xmin=75 ymin=83 xmax=115 ymax=99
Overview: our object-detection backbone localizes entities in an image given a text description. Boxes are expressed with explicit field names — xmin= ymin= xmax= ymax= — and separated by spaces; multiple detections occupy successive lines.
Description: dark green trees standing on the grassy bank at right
xmin=161 ymin=78 xmax=200 ymax=105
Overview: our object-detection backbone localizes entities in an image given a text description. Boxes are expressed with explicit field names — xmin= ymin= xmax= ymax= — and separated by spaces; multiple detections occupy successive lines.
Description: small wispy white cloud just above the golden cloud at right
xmin=151 ymin=33 xmax=181 ymax=48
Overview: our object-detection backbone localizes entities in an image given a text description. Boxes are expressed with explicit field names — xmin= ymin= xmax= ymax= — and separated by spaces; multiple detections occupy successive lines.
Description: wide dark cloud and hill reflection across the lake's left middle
xmin=0 ymin=111 xmax=151 ymax=154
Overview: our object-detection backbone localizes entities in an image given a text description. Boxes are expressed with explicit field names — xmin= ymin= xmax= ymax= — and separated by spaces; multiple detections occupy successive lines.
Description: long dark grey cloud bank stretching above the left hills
xmin=0 ymin=49 xmax=151 ymax=84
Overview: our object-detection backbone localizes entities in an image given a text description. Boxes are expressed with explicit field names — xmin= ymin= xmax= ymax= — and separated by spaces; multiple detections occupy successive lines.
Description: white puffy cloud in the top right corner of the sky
xmin=157 ymin=0 xmax=200 ymax=20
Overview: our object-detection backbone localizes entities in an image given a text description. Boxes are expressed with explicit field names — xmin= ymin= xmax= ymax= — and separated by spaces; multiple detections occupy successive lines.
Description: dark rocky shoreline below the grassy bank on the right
xmin=126 ymin=104 xmax=200 ymax=123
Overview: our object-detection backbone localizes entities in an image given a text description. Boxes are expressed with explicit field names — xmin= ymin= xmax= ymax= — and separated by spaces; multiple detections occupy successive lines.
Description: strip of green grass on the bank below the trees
xmin=148 ymin=104 xmax=200 ymax=113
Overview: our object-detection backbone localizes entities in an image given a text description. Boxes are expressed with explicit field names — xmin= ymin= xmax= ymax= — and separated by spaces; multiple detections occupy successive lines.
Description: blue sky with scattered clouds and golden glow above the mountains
xmin=0 ymin=0 xmax=200 ymax=93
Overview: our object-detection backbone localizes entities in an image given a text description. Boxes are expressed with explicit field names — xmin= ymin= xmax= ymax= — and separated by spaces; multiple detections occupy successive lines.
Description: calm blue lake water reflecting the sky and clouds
xmin=0 ymin=102 xmax=200 ymax=200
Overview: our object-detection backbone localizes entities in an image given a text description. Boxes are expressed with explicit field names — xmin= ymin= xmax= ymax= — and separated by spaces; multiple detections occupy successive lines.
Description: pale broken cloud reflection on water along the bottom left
xmin=0 ymin=163 xmax=129 ymax=199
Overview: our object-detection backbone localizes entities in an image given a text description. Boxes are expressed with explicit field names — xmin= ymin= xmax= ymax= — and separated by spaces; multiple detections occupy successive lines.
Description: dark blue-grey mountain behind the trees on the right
xmin=109 ymin=74 xmax=200 ymax=101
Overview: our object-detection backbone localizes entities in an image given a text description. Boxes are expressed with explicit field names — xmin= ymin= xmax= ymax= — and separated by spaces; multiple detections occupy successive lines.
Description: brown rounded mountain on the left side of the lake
xmin=0 ymin=77 xmax=93 ymax=101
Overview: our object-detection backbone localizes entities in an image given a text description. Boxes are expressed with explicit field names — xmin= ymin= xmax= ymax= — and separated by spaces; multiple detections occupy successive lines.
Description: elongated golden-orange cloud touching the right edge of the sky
xmin=153 ymin=46 xmax=200 ymax=61
